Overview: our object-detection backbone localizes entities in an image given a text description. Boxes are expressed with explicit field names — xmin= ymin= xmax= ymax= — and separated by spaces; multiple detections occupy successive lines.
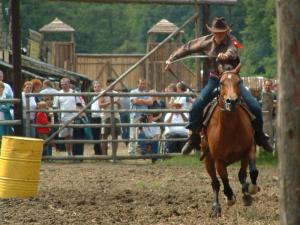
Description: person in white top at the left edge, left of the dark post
xmin=0 ymin=81 xmax=13 ymax=137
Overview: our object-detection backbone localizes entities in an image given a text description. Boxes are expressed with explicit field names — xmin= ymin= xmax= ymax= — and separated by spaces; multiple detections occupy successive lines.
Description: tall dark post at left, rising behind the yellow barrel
xmin=11 ymin=0 xmax=23 ymax=136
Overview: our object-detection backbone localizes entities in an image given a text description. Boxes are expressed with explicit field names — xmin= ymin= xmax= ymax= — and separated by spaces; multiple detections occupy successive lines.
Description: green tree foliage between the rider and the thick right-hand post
xmin=241 ymin=0 xmax=276 ymax=77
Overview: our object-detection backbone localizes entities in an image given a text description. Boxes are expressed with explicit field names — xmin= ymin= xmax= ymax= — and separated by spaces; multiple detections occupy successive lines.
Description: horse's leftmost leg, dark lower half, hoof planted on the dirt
xmin=204 ymin=154 xmax=221 ymax=217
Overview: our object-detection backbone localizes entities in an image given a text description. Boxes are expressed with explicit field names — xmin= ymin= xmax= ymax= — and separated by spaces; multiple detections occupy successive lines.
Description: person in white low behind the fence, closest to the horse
xmin=164 ymin=101 xmax=188 ymax=153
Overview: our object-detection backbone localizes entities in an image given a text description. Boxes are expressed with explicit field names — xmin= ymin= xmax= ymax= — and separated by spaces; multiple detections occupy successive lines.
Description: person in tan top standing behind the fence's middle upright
xmin=100 ymin=79 xmax=121 ymax=155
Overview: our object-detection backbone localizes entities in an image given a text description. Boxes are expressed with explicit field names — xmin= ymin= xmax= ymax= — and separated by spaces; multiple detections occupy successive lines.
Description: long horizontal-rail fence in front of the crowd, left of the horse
xmin=25 ymin=92 xmax=196 ymax=161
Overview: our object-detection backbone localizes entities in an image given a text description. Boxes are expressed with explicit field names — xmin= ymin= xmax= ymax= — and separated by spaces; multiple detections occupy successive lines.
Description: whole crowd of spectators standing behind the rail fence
xmin=0 ymin=68 xmax=276 ymax=158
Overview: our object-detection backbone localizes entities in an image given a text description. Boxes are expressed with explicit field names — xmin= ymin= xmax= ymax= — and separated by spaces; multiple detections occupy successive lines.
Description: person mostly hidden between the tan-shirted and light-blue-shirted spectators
xmin=120 ymin=89 xmax=130 ymax=147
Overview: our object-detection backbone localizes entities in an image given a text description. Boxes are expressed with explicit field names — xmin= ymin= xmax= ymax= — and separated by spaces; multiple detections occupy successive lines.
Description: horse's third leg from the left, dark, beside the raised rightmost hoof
xmin=239 ymin=158 xmax=252 ymax=206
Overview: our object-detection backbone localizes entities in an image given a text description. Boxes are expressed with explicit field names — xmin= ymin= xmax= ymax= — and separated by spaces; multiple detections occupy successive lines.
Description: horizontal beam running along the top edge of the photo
xmin=49 ymin=0 xmax=238 ymax=5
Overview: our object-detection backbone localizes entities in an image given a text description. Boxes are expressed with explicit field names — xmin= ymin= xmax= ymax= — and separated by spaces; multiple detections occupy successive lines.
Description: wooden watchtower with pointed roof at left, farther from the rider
xmin=39 ymin=18 xmax=76 ymax=71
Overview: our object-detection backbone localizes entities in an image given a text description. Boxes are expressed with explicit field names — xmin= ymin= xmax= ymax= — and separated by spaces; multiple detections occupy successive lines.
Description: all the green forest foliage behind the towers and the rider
xmin=2 ymin=0 xmax=277 ymax=77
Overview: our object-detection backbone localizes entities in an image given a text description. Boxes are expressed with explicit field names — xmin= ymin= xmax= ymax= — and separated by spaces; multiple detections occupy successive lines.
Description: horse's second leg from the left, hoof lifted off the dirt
xmin=216 ymin=162 xmax=236 ymax=206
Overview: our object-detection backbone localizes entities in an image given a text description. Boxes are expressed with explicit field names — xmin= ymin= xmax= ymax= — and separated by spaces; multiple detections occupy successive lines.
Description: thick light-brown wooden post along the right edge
xmin=277 ymin=0 xmax=300 ymax=225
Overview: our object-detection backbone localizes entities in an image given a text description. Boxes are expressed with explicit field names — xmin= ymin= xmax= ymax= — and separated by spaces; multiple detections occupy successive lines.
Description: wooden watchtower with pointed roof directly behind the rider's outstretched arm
xmin=146 ymin=19 xmax=195 ymax=91
